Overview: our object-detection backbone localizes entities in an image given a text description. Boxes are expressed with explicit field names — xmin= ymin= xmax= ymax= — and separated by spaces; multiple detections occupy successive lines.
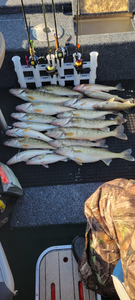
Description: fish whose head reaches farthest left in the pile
xmin=3 ymin=138 xmax=55 ymax=149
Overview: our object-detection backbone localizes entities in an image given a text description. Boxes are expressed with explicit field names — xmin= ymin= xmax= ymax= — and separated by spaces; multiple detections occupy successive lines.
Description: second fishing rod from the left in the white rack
xmin=41 ymin=0 xmax=57 ymax=76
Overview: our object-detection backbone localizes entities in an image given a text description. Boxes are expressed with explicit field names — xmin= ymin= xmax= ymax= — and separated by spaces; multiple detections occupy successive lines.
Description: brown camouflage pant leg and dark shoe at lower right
xmin=78 ymin=178 xmax=135 ymax=300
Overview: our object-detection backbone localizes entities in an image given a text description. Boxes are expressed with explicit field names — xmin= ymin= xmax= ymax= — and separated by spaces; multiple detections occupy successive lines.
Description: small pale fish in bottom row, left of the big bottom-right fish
xmin=26 ymin=153 xmax=68 ymax=168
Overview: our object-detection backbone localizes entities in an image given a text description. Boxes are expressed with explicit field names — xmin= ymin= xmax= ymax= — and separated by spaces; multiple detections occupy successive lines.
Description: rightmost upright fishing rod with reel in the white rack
xmin=74 ymin=0 xmax=83 ymax=74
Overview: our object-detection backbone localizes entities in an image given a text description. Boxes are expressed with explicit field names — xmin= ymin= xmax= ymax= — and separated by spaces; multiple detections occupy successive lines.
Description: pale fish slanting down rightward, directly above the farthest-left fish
xmin=5 ymin=128 xmax=51 ymax=142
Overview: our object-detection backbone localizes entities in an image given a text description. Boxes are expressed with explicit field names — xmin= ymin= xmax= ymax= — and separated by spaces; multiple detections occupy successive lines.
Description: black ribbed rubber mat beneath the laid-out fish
xmin=0 ymin=80 xmax=135 ymax=187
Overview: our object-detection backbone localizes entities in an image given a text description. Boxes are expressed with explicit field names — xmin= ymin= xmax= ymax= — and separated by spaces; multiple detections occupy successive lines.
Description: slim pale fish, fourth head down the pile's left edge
xmin=12 ymin=122 xmax=57 ymax=131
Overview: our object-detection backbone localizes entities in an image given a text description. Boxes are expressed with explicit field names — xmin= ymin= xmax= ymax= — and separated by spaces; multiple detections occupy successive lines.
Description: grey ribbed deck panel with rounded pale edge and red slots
xmin=35 ymin=245 xmax=101 ymax=300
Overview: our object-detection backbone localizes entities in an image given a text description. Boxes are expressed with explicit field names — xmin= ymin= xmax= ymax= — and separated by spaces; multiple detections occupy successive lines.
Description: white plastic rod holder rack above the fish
xmin=12 ymin=51 xmax=98 ymax=88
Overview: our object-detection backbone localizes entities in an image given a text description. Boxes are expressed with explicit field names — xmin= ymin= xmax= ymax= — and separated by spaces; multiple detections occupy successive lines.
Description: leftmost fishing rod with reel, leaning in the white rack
xmin=21 ymin=0 xmax=38 ymax=68
